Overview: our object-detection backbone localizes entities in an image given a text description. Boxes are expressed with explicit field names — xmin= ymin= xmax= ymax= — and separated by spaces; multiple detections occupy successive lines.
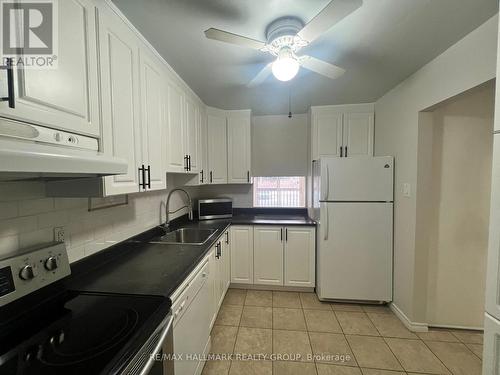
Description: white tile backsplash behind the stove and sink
xmin=0 ymin=181 xmax=198 ymax=262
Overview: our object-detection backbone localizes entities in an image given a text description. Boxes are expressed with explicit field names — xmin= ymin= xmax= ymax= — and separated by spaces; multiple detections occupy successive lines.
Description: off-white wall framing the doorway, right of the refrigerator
xmin=375 ymin=16 xmax=498 ymax=322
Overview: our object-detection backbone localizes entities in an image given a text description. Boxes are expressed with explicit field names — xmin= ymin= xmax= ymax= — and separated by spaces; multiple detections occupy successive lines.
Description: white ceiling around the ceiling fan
xmin=113 ymin=0 xmax=498 ymax=114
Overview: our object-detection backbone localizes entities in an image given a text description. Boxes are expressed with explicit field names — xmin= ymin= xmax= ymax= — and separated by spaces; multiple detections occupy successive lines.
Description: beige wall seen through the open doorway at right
xmin=417 ymin=83 xmax=495 ymax=328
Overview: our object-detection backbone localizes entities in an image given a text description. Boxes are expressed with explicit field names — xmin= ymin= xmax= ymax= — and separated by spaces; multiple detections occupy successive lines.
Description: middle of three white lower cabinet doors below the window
xmin=253 ymin=226 xmax=283 ymax=285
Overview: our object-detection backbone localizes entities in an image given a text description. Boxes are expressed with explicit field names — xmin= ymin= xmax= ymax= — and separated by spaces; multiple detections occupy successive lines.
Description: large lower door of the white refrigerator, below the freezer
xmin=317 ymin=203 xmax=392 ymax=302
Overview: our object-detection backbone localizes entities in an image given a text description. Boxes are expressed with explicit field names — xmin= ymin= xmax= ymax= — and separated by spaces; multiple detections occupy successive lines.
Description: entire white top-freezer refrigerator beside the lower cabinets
xmin=313 ymin=157 xmax=394 ymax=302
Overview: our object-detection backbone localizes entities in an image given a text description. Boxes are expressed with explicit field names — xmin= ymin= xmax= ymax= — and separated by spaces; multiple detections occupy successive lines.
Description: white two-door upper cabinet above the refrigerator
xmin=310 ymin=104 xmax=375 ymax=160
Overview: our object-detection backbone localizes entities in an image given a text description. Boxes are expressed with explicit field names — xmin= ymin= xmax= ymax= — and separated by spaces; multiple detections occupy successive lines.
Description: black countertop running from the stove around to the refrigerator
xmin=67 ymin=209 xmax=316 ymax=297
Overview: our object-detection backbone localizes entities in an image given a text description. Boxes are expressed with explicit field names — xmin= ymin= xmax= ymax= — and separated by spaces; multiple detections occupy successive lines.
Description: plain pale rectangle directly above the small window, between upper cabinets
xmin=252 ymin=114 xmax=308 ymax=177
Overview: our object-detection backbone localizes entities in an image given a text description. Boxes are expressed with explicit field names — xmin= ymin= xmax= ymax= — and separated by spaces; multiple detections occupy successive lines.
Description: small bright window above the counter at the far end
xmin=253 ymin=177 xmax=306 ymax=207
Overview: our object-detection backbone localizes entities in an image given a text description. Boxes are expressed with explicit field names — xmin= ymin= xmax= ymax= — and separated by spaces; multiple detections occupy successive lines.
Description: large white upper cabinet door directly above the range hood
xmin=0 ymin=0 xmax=100 ymax=136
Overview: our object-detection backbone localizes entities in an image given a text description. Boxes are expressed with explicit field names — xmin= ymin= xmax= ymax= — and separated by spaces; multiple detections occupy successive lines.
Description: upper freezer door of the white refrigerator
xmin=320 ymin=156 xmax=394 ymax=202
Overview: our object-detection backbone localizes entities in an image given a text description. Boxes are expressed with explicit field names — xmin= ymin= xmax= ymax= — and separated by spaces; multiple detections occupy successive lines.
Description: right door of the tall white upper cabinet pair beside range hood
xmin=141 ymin=50 xmax=167 ymax=190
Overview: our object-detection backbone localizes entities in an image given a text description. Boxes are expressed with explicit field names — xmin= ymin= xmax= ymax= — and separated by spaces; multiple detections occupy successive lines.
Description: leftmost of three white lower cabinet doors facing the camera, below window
xmin=230 ymin=225 xmax=253 ymax=284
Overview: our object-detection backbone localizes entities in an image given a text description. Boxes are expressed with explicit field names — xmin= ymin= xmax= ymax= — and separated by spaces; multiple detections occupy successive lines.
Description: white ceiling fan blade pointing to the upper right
xmin=298 ymin=0 xmax=363 ymax=43
